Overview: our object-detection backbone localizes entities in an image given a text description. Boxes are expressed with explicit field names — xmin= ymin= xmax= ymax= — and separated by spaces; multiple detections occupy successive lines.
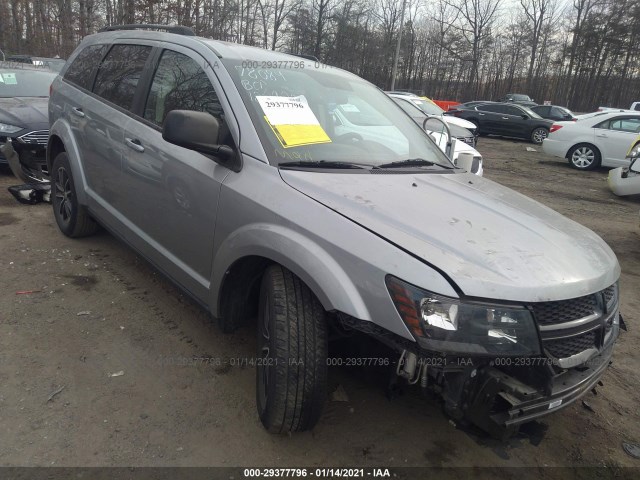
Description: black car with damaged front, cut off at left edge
xmin=0 ymin=62 xmax=56 ymax=183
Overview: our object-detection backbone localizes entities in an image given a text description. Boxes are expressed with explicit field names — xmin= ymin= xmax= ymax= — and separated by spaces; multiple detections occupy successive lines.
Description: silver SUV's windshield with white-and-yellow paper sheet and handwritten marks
xmin=222 ymin=59 xmax=451 ymax=168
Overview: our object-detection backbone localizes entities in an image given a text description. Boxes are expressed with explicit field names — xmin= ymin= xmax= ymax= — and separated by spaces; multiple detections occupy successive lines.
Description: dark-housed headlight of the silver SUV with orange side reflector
xmin=386 ymin=275 xmax=540 ymax=356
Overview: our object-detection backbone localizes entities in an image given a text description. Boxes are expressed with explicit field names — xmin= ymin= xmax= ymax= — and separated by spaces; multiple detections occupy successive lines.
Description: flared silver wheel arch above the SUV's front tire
xmin=210 ymin=223 xmax=371 ymax=320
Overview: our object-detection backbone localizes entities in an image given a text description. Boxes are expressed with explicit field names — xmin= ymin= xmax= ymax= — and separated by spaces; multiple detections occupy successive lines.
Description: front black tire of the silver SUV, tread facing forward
xmin=256 ymin=265 xmax=327 ymax=433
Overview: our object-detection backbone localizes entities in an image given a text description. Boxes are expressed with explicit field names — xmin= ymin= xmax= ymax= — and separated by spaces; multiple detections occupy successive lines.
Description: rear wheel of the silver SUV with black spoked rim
xmin=51 ymin=152 xmax=98 ymax=238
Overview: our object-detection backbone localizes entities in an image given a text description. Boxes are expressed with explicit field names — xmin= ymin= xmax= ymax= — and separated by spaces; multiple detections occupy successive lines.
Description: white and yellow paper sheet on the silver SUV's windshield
xmin=256 ymin=95 xmax=331 ymax=148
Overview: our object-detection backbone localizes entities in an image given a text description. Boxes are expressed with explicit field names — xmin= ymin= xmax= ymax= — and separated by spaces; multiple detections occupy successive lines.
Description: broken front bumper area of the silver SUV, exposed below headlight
xmin=341 ymin=310 xmax=626 ymax=440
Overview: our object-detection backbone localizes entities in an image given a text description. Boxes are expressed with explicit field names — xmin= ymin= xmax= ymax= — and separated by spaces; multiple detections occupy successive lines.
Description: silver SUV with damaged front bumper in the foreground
xmin=47 ymin=25 xmax=623 ymax=437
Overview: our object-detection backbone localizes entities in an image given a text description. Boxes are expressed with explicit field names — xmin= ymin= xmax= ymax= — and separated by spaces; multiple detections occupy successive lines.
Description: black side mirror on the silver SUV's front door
xmin=162 ymin=110 xmax=240 ymax=171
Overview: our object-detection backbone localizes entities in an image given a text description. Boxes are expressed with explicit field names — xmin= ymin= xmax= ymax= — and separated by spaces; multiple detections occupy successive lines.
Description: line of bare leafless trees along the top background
xmin=0 ymin=0 xmax=640 ymax=111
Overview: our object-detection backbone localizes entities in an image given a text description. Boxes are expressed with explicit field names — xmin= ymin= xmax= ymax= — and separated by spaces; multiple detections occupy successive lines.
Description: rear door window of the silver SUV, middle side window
xmin=93 ymin=44 xmax=151 ymax=110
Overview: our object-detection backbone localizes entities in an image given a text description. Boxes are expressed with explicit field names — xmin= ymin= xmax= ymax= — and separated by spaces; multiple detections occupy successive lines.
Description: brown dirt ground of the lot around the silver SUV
xmin=0 ymin=138 xmax=640 ymax=472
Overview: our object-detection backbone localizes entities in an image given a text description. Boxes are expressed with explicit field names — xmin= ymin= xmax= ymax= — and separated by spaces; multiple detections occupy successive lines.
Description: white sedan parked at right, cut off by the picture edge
xmin=542 ymin=111 xmax=640 ymax=170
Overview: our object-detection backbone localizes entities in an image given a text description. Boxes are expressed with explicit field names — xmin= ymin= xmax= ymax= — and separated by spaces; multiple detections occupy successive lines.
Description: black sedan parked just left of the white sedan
xmin=444 ymin=103 xmax=553 ymax=144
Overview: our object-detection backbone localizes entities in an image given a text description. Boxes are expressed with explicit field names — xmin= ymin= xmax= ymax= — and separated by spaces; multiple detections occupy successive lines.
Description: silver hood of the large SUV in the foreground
xmin=281 ymin=170 xmax=620 ymax=302
